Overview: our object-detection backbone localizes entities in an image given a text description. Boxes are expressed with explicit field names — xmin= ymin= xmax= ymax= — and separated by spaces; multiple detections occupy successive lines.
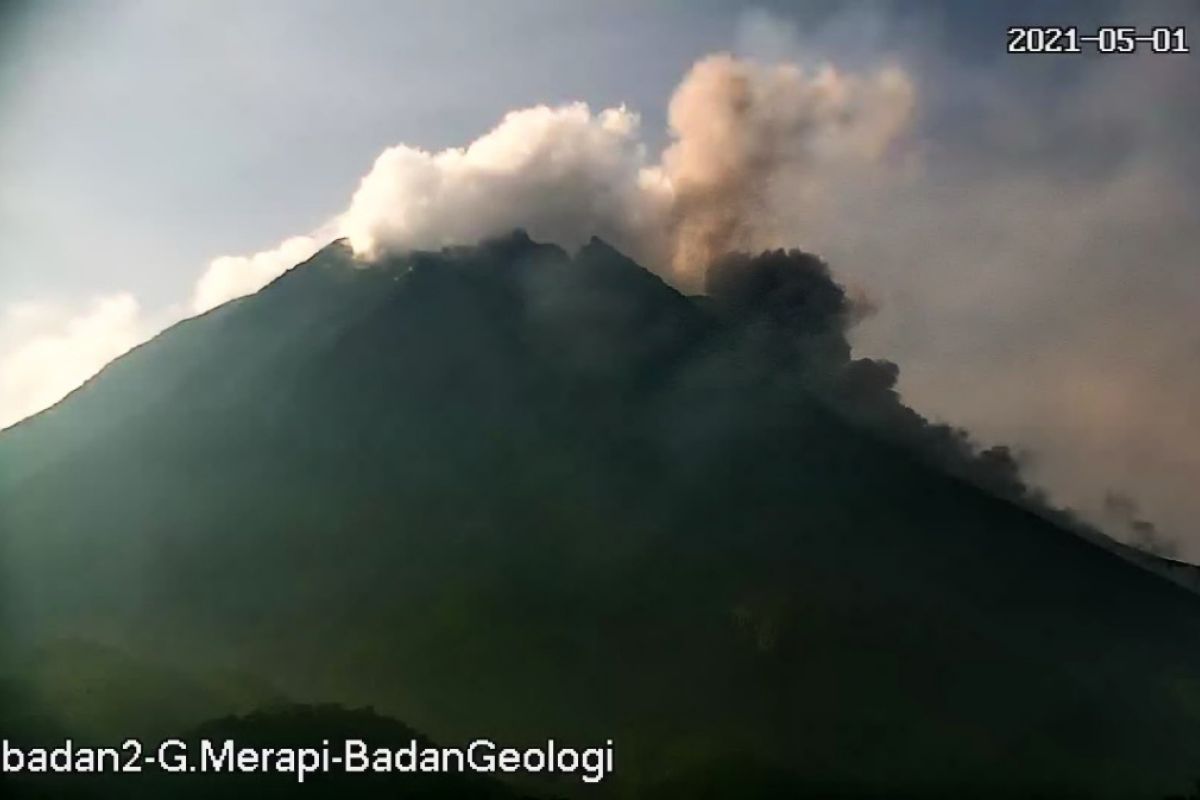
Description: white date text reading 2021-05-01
xmin=1008 ymin=25 xmax=1190 ymax=54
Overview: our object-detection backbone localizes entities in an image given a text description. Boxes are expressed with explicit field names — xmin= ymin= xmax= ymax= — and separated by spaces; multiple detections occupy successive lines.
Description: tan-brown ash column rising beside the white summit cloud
xmin=660 ymin=55 xmax=914 ymax=281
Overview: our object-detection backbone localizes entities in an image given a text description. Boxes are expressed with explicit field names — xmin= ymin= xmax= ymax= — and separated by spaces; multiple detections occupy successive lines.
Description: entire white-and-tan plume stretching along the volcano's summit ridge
xmin=193 ymin=55 xmax=914 ymax=311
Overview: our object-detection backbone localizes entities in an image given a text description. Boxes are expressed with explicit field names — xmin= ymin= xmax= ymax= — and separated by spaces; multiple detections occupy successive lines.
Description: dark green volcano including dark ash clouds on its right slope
xmin=0 ymin=235 xmax=1200 ymax=798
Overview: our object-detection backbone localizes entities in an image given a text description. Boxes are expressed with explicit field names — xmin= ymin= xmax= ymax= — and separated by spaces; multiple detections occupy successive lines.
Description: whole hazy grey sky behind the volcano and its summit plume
xmin=0 ymin=0 xmax=1200 ymax=560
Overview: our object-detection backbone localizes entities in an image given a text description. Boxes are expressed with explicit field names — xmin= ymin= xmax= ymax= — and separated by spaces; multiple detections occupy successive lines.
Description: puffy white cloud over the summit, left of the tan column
xmin=340 ymin=103 xmax=654 ymax=266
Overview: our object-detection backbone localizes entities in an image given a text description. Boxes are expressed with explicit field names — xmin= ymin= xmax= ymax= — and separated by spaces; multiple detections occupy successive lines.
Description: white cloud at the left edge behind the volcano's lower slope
xmin=0 ymin=294 xmax=155 ymax=428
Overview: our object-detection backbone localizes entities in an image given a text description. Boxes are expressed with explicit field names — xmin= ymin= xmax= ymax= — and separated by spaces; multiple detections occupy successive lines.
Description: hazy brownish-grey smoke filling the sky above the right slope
xmin=742 ymin=4 xmax=1200 ymax=560
